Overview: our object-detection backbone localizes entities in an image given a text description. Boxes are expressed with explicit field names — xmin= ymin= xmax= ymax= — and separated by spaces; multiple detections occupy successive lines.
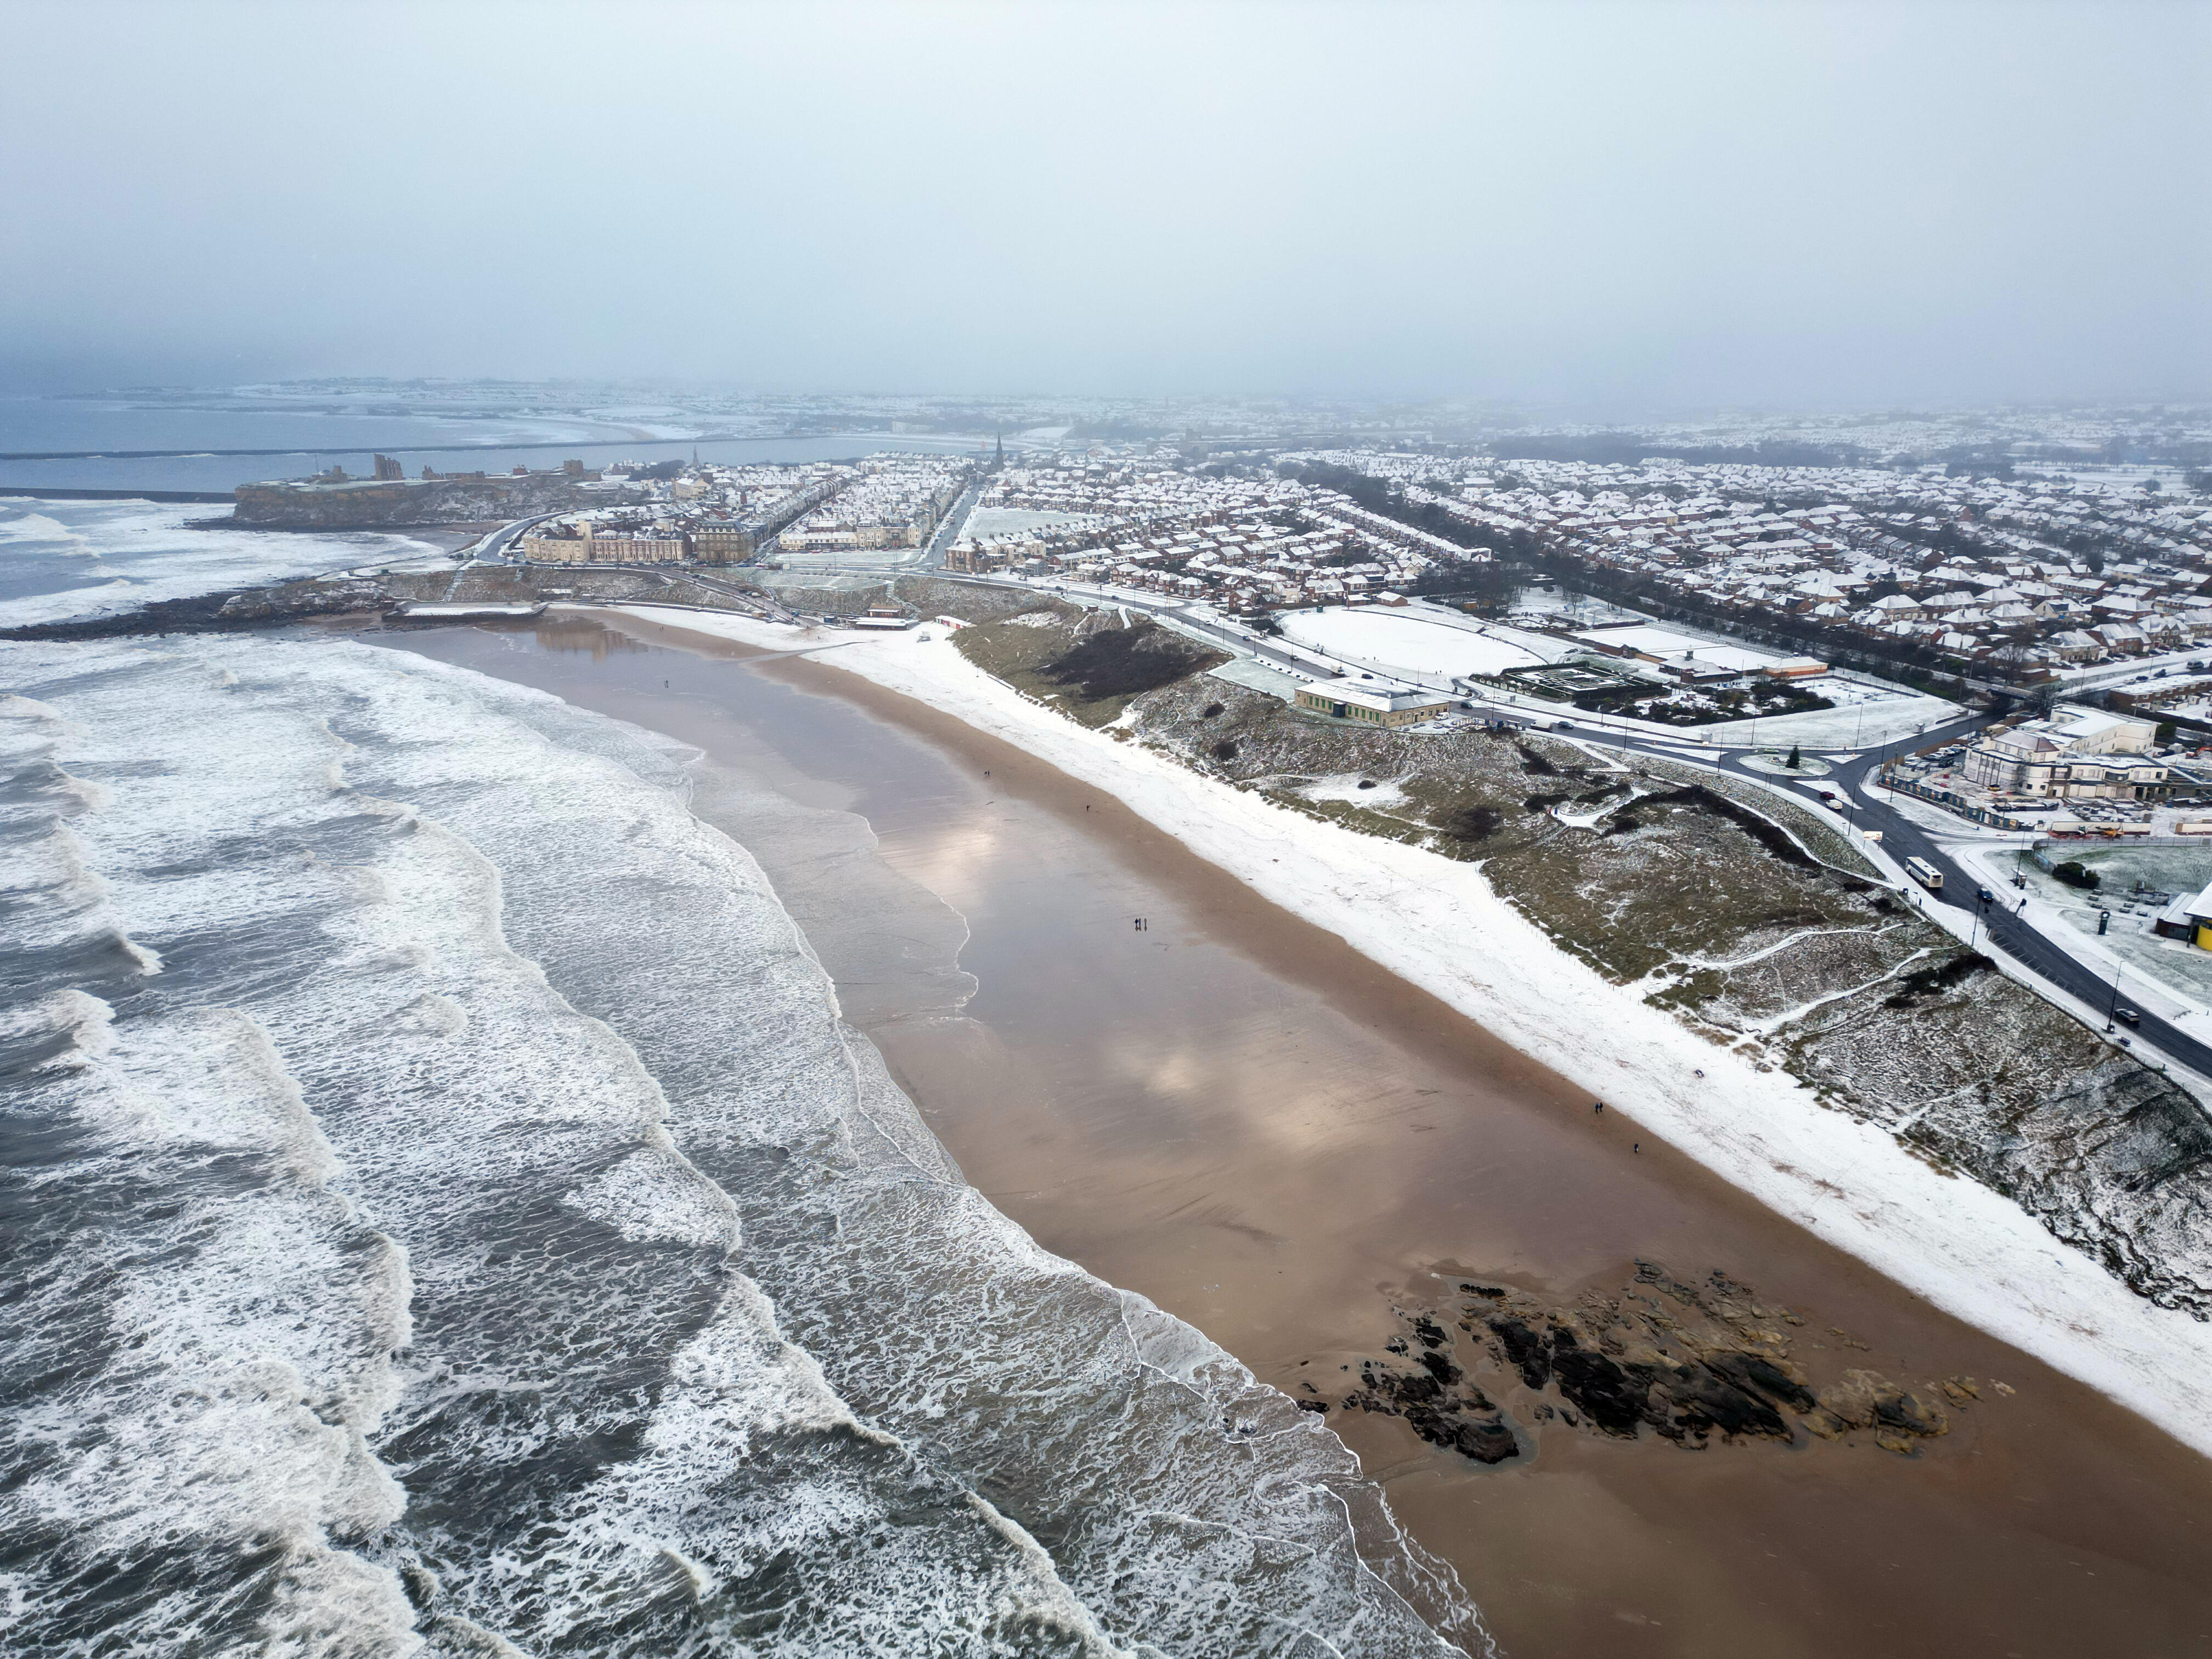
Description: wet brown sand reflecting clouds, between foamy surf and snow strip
xmin=381 ymin=617 xmax=2212 ymax=1659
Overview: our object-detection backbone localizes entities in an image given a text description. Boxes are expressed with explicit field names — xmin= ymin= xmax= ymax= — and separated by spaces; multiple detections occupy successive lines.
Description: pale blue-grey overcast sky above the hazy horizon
xmin=0 ymin=0 xmax=2212 ymax=414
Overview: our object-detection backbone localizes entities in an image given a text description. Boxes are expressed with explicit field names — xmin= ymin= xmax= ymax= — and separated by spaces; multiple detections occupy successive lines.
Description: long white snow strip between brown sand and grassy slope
xmin=597 ymin=606 xmax=2212 ymax=1453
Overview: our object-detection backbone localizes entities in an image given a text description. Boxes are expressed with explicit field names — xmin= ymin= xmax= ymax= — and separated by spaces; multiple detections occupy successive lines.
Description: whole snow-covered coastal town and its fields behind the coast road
xmin=185 ymin=411 xmax=2212 ymax=1092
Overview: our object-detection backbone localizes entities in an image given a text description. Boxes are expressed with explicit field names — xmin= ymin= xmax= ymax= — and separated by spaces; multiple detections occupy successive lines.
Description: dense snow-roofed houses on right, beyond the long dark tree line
xmin=1301 ymin=452 xmax=2212 ymax=679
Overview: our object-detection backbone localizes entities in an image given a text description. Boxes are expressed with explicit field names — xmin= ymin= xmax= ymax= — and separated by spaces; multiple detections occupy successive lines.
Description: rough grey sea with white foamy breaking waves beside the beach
xmin=0 ymin=502 xmax=1489 ymax=1659
